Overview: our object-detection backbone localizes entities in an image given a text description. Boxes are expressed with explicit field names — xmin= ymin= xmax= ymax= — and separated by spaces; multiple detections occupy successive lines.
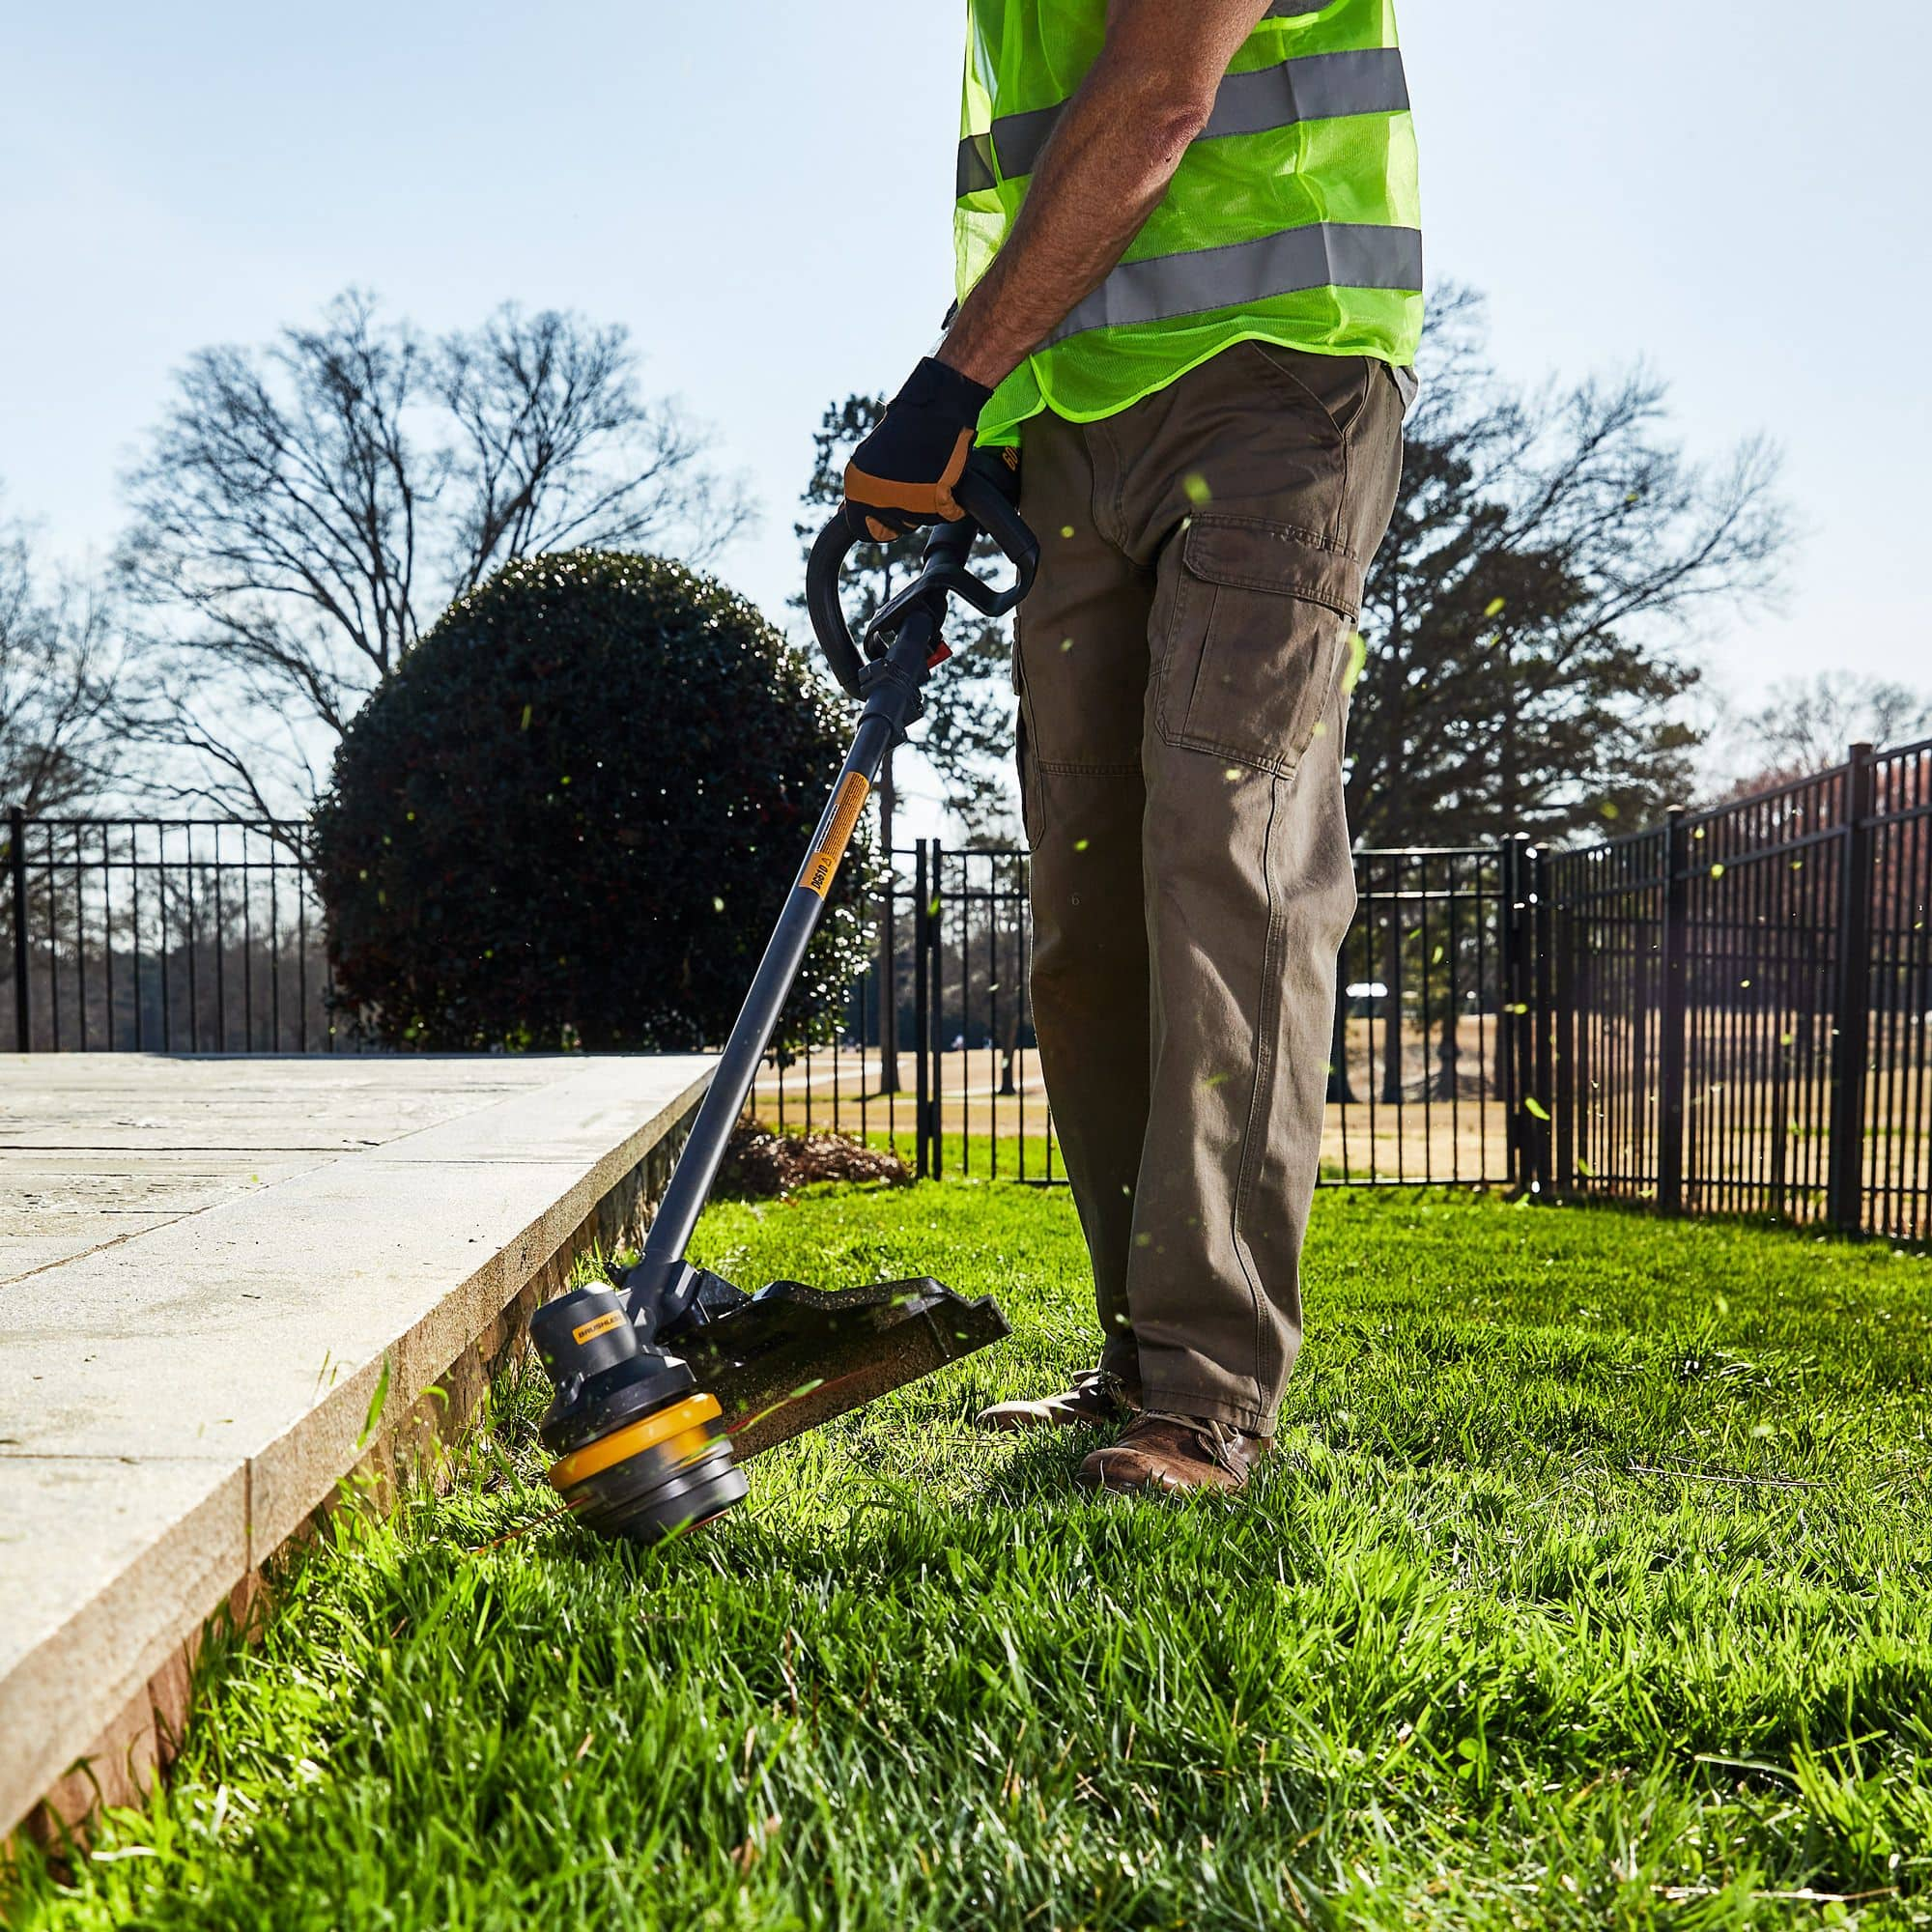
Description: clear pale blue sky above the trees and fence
xmin=0 ymin=0 xmax=1932 ymax=738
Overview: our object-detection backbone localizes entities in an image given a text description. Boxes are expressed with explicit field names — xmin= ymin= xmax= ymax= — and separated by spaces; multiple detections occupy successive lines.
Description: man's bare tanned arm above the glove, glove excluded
xmin=939 ymin=0 xmax=1267 ymax=388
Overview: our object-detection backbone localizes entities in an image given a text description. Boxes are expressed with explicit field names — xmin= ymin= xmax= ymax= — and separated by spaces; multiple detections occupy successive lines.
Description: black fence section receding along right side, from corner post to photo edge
xmin=1524 ymin=742 xmax=1932 ymax=1242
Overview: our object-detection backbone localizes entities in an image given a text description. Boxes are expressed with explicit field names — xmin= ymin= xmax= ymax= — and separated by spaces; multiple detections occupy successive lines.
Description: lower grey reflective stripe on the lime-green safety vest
xmin=1047 ymin=222 xmax=1422 ymax=346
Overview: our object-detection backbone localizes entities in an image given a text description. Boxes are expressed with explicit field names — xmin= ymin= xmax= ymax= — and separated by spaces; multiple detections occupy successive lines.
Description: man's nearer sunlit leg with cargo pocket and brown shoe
xmin=1090 ymin=344 xmax=1401 ymax=1486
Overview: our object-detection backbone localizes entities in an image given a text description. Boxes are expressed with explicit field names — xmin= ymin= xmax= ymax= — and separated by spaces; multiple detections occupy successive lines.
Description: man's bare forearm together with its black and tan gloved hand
xmin=846 ymin=0 xmax=1267 ymax=541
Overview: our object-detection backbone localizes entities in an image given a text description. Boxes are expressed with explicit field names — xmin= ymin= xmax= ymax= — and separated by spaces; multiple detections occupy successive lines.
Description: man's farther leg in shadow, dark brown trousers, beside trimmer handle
xmin=1018 ymin=404 xmax=1153 ymax=1387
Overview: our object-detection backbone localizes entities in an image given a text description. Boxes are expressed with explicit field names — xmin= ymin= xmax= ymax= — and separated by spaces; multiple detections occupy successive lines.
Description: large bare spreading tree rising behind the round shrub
xmin=120 ymin=290 xmax=748 ymax=815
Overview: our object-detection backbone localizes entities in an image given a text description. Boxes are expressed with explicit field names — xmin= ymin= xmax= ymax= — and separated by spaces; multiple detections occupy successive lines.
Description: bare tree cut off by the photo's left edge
xmin=0 ymin=491 xmax=118 ymax=813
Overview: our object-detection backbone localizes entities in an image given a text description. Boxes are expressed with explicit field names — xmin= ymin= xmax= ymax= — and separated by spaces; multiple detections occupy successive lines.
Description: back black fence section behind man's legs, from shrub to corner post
xmin=753 ymin=840 xmax=1532 ymax=1186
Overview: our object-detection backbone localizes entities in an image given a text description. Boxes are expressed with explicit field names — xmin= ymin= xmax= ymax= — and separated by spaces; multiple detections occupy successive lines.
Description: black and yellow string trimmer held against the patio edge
xmin=529 ymin=466 xmax=1039 ymax=1542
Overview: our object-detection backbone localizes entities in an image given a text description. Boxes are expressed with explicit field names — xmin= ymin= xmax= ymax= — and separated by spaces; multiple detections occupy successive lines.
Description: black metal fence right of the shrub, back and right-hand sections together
xmin=757 ymin=740 xmax=1932 ymax=1242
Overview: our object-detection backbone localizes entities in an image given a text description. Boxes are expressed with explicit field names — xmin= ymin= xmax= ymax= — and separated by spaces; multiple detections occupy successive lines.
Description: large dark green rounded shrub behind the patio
xmin=315 ymin=551 xmax=866 ymax=1051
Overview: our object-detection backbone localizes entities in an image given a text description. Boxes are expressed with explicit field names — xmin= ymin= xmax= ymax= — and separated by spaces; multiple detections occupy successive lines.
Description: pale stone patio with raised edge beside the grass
xmin=0 ymin=1055 xmax=711 ymax=1837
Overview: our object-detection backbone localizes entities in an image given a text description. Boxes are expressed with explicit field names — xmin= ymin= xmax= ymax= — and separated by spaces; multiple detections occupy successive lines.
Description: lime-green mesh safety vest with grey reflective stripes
xmin=954 ymin=0 xmax=1422 ymax=442
